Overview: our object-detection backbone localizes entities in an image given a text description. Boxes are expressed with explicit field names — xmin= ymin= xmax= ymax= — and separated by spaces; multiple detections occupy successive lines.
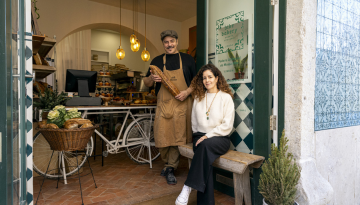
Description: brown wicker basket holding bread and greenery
xmin=39 ymin=125 xmax=99 ymax=151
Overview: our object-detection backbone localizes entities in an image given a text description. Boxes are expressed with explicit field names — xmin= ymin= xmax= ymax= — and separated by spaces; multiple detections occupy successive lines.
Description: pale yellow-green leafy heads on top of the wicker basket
xmin=47 ymin=105 xmax=81 ymax=128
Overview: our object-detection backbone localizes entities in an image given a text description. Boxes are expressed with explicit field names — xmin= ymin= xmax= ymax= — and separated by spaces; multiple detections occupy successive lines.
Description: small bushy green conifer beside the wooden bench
xmin=259 ymin=131 xmax=300 ymax=205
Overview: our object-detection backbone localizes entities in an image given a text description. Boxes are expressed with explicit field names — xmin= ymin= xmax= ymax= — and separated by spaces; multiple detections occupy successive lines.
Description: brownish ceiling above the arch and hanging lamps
xmin=89 ymin=0 xmax=196 ymax=22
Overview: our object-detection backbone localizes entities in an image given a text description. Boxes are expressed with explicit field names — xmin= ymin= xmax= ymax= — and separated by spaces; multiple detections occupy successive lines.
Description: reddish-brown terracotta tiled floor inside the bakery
xmin=34 ymin=143 xmax=235 ymax=205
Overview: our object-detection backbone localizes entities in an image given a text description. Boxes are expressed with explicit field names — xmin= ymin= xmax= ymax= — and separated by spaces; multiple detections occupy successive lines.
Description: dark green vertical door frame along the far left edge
xmin=0 ymin=0 xmax=13 ymax=204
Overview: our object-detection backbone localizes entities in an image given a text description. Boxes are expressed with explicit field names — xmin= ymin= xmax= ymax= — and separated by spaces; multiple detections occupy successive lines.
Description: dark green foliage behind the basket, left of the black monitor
xmin=34 ymin=88 xmax=68 ymax=110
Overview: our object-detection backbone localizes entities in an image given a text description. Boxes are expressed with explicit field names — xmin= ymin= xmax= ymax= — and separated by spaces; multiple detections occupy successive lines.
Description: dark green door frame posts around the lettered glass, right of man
xmin=196 ymin=0 xmax=286 ymax=205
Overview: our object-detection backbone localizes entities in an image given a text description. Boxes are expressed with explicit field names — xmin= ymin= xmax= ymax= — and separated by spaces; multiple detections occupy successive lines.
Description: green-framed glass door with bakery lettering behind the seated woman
xmin=202 ymin=0 xmax=273 ymax=204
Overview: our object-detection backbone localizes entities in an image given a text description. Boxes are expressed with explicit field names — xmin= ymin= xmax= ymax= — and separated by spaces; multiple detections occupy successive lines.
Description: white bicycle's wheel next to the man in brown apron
xmin=124 ymin=118 xmax=160 ymax=164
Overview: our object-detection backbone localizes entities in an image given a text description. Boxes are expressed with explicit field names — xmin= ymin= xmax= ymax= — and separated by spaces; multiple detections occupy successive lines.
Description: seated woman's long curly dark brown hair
xmin=190 ymin=64 xmax=234 ymax=101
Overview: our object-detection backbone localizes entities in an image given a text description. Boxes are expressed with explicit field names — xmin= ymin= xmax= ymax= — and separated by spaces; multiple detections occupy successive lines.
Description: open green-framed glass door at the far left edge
xmin=0 ymin=0 xmax=26 ymax=204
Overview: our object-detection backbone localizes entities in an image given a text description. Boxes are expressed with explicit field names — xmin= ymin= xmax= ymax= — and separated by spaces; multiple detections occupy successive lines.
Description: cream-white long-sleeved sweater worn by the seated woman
xmin=191 ymin=91 xmax=235 ymax=138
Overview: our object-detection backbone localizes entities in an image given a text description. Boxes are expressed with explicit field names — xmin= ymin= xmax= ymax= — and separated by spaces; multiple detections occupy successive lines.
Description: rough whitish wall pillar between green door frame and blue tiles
xmin=285 ymin=0 xmax=334 ymax=205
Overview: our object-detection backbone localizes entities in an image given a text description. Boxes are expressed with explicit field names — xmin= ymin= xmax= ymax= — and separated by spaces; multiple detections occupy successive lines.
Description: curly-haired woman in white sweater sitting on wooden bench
xmin=175 ymin=64 xmax=235 ymax=205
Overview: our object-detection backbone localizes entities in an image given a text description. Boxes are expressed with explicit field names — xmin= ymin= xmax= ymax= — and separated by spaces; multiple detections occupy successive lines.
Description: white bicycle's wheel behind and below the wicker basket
xmin=33 ymin=132 xmax=94 ymax=178
